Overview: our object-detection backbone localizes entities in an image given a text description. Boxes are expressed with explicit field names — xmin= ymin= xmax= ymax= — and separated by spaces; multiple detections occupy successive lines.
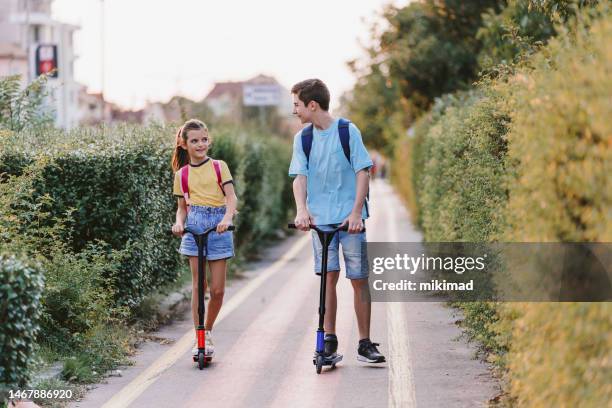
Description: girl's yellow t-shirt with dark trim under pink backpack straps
xmin=174 ymin=157 xmax=234 ymax=207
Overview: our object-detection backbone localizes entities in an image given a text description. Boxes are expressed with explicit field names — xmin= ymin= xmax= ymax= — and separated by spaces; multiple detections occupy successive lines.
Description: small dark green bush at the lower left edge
xmin=0 ymin=254 xmax=43 ymax=400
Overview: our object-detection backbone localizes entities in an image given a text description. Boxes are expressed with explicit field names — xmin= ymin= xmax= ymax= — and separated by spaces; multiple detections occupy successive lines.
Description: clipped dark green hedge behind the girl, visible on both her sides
xmin=0 ymin=125 xmax=289 ymax=305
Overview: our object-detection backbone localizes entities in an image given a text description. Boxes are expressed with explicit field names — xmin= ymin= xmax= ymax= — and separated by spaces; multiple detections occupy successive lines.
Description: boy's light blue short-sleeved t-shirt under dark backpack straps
xmin=289 ymin=119 xmax=372 ymax=225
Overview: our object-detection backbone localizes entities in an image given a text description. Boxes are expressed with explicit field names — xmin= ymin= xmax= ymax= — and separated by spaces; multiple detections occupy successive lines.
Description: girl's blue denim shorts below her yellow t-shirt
xmin=179 ymin=205 xmax=234 ymax=261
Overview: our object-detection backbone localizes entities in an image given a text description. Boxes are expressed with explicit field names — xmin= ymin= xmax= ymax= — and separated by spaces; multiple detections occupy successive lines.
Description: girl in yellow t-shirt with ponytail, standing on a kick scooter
xmin=172 ymin=119 xmax=237 ymax=356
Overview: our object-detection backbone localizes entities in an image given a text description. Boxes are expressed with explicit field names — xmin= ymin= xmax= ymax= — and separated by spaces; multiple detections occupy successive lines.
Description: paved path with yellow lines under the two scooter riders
xmin=71 ymin=180 xmax=498 ymax=407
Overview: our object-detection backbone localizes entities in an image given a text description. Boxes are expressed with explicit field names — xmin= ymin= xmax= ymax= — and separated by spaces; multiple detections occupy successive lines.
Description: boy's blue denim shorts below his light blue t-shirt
xmin=312 ymin=224 xmax=368 ymax=279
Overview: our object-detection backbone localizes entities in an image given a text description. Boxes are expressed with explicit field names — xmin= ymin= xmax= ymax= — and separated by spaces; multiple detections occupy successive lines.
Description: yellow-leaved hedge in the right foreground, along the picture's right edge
xmin=500 ymin=14 xmax=612 ymax=407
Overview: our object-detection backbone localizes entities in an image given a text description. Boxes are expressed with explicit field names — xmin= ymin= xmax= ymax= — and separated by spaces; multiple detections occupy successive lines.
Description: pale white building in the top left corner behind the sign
xmin=0 ymin=0 xmax=80 ymax=128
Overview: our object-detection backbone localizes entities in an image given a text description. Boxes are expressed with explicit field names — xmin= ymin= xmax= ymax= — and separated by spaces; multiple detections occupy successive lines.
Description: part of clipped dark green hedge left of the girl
xmin=0 ymin=127 xmax=178 ymax=304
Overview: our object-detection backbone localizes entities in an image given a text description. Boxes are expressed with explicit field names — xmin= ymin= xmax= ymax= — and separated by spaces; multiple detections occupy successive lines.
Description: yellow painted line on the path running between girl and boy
xmin=102 ymin=234 xmax=311 ymax=408
